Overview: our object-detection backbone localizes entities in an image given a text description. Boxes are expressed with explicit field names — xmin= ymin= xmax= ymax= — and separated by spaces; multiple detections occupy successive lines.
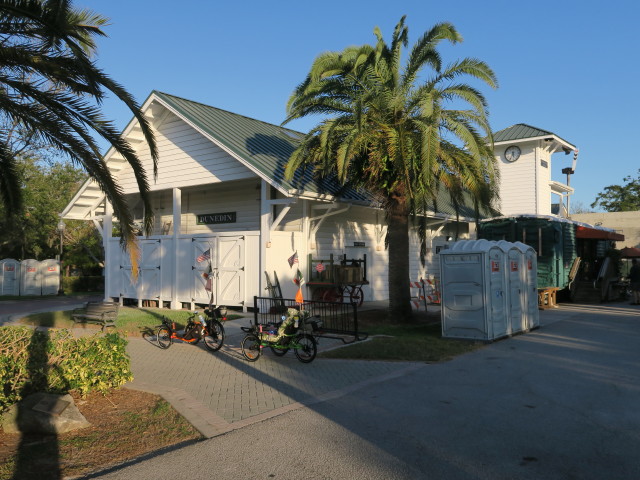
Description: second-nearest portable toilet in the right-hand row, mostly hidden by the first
xmin=498 ymin=240 xmax=527 ymax=334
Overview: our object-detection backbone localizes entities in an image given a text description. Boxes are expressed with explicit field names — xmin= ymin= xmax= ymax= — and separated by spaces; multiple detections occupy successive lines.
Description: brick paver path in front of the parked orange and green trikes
xmin=127 ymin=335 xmax=416 ymax=436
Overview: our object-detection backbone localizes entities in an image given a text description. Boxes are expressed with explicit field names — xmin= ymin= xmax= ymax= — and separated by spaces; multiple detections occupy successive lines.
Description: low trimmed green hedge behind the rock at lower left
xmin=0 ymin=326 xmax=133 ymax=412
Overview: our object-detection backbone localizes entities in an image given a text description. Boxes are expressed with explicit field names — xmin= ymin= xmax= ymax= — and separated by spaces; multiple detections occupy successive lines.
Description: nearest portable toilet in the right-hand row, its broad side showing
xmin=440 ymin=240 xmax=509 ymax=340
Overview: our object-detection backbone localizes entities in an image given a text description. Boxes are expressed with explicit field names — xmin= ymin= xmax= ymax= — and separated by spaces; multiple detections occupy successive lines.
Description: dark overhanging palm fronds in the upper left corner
xmin=0 ymin=0 xmax=157 ymax=260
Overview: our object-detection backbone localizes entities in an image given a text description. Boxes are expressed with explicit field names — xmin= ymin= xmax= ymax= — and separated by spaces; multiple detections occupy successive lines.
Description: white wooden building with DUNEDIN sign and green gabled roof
xmin=62 ymin=91 xmax=473 ymax=309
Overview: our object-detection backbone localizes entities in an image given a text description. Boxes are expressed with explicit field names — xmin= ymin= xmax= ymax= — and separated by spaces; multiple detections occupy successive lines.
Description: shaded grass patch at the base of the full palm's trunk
xmin=319 ymin=316 xmax=484 ymax=362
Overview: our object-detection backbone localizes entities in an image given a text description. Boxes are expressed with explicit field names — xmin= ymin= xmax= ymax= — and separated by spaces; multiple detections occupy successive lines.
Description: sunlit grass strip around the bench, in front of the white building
xmin=19 ymin=307 xmax=240 ymax=335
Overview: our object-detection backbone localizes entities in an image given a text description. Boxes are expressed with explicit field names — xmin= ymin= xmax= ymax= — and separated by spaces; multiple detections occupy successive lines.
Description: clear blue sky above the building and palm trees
xmin=82 ymin=0 xmax=640 ymax=211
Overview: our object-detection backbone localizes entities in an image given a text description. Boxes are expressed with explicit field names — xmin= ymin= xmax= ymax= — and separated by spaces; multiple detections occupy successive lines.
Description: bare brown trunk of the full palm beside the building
xmin=387 ymin=197 xmax=412 ymax=323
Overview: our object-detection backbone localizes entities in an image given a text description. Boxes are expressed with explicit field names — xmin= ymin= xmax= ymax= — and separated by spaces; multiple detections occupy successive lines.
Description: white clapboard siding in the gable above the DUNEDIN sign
xmin=117 ymin=111 xmax=255 ymax=193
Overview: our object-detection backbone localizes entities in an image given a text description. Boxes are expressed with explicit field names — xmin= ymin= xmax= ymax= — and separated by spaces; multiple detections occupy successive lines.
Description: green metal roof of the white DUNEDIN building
xmin=152 ymin=91 xmax=490 ymax=218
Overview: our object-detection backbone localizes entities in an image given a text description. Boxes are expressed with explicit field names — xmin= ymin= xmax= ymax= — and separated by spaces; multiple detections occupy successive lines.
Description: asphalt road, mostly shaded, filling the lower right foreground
xmin=88 ymin=305 xmax=640 ymax=480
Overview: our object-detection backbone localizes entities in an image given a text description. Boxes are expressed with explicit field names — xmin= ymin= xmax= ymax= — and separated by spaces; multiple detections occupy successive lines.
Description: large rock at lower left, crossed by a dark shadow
xmin=2 ymin=393 xmax=91 ymax=434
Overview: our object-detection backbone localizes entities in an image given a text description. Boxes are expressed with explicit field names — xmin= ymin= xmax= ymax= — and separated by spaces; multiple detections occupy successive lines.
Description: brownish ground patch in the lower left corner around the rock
xmin=0 ymin=388 xmax=202 ymax=480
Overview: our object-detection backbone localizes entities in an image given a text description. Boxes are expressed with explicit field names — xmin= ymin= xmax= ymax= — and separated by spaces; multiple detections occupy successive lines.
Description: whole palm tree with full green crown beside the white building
xmin=283 ymin=17 xmax=497 ymax=320
